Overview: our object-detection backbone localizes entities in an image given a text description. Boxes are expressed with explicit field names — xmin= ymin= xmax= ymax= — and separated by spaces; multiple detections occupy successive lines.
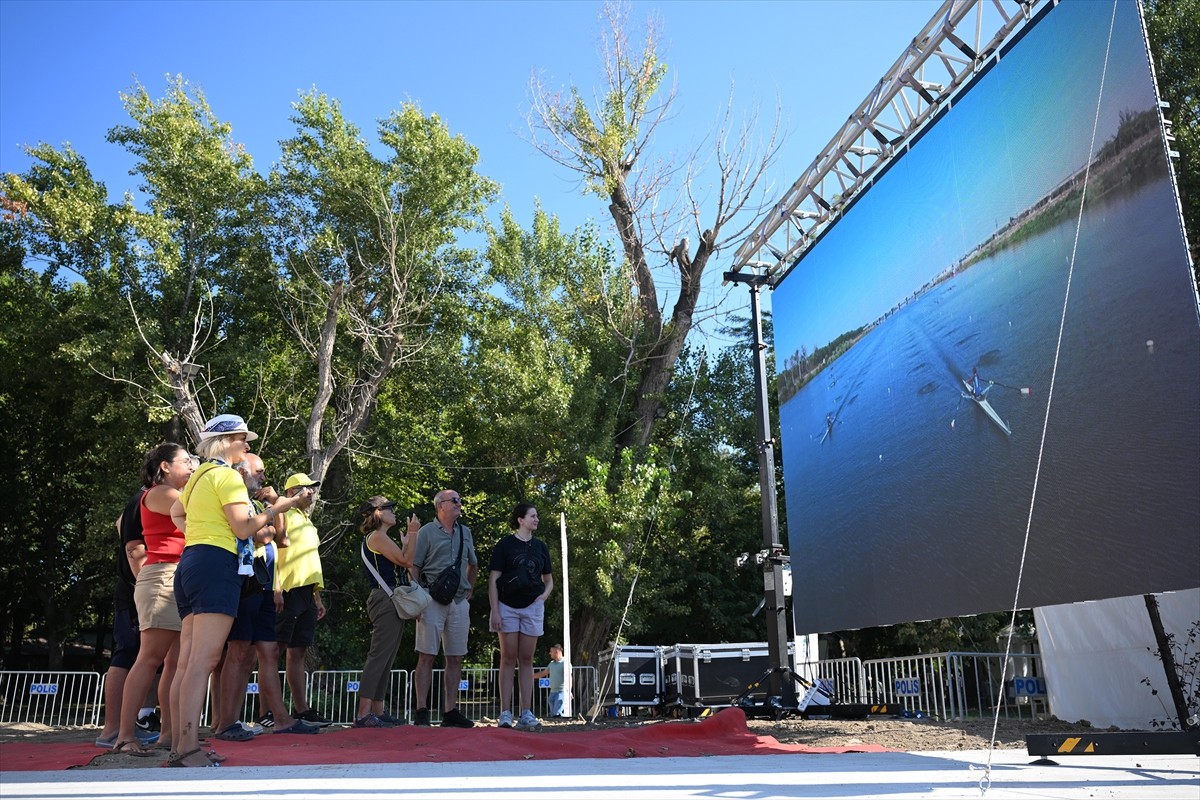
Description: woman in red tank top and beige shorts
xmin=113 ymin=443 xmax=197 ymax=754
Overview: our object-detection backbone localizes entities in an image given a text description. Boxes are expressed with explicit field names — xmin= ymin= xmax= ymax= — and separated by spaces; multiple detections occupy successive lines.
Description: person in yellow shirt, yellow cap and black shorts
xmin=275 ymin=473 xmax=331 ymax=727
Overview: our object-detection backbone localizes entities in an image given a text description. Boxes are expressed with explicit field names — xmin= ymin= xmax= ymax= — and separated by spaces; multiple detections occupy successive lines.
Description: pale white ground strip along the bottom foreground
xmin=0 ymin=750 xmax=1200 ymax=800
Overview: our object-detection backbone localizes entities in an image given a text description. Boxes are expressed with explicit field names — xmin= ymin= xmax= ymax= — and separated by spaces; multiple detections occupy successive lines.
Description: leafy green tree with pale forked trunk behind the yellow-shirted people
xmin=271 ymin=91 xmax=496 ymax=479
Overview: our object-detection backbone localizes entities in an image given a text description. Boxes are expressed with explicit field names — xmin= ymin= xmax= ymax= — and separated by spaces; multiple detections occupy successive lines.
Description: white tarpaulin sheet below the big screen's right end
xmin=1033 ymin=589 xmax=1200 ymax=730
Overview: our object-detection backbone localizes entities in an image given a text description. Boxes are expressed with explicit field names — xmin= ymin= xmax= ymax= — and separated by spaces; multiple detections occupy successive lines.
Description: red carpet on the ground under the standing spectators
xmin=0 ymin=709 xmax=887 ymax=771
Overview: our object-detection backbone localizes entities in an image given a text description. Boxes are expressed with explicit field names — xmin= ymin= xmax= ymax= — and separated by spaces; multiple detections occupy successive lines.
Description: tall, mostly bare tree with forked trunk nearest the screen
xmin=527 ymin=2 xmax=780 ymax=447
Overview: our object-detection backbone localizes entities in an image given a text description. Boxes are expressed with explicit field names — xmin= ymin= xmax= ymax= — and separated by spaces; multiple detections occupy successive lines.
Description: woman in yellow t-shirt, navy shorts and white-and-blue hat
xmin=167 ymin=414 xmax=312 ymax=766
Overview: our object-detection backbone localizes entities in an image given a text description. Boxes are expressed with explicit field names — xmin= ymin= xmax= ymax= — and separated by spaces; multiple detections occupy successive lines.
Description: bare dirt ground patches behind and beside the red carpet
xmin=0 ymin=717 xmax=1092 ymax=769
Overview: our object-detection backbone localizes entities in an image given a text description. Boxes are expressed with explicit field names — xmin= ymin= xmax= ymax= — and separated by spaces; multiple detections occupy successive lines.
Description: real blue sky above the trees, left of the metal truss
xmin=0 ymin=0 xmax=941 ymax=345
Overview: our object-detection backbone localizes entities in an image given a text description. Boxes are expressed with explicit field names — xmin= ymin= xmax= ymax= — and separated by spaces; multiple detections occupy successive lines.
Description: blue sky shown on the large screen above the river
xmin=774 ymin=0 xmax=1154 ymax=363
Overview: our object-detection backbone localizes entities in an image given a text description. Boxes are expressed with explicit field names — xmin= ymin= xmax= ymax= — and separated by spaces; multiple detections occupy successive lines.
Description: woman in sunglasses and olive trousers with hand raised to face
xmin=354 ymin=497 xmax=421 ymax=728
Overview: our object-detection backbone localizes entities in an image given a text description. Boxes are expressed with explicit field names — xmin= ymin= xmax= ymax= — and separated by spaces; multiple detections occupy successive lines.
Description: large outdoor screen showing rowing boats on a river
xmin=772 ymin=0 xmax=1200 ymax=633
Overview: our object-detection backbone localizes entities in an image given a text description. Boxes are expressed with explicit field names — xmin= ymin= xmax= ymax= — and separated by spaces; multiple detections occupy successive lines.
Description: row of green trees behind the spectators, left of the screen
xmin=0 ymin=0 xmax=1190 ymax=669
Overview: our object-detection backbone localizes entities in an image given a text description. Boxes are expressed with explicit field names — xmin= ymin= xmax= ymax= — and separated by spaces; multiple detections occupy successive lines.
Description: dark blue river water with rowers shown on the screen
xmin=780 ymin=180 xmax=1200 ymax=632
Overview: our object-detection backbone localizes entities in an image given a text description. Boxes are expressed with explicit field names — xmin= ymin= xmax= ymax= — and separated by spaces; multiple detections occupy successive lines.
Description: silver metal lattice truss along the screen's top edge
xmin=732 ymin=0 xmax=1058 ymax=283
